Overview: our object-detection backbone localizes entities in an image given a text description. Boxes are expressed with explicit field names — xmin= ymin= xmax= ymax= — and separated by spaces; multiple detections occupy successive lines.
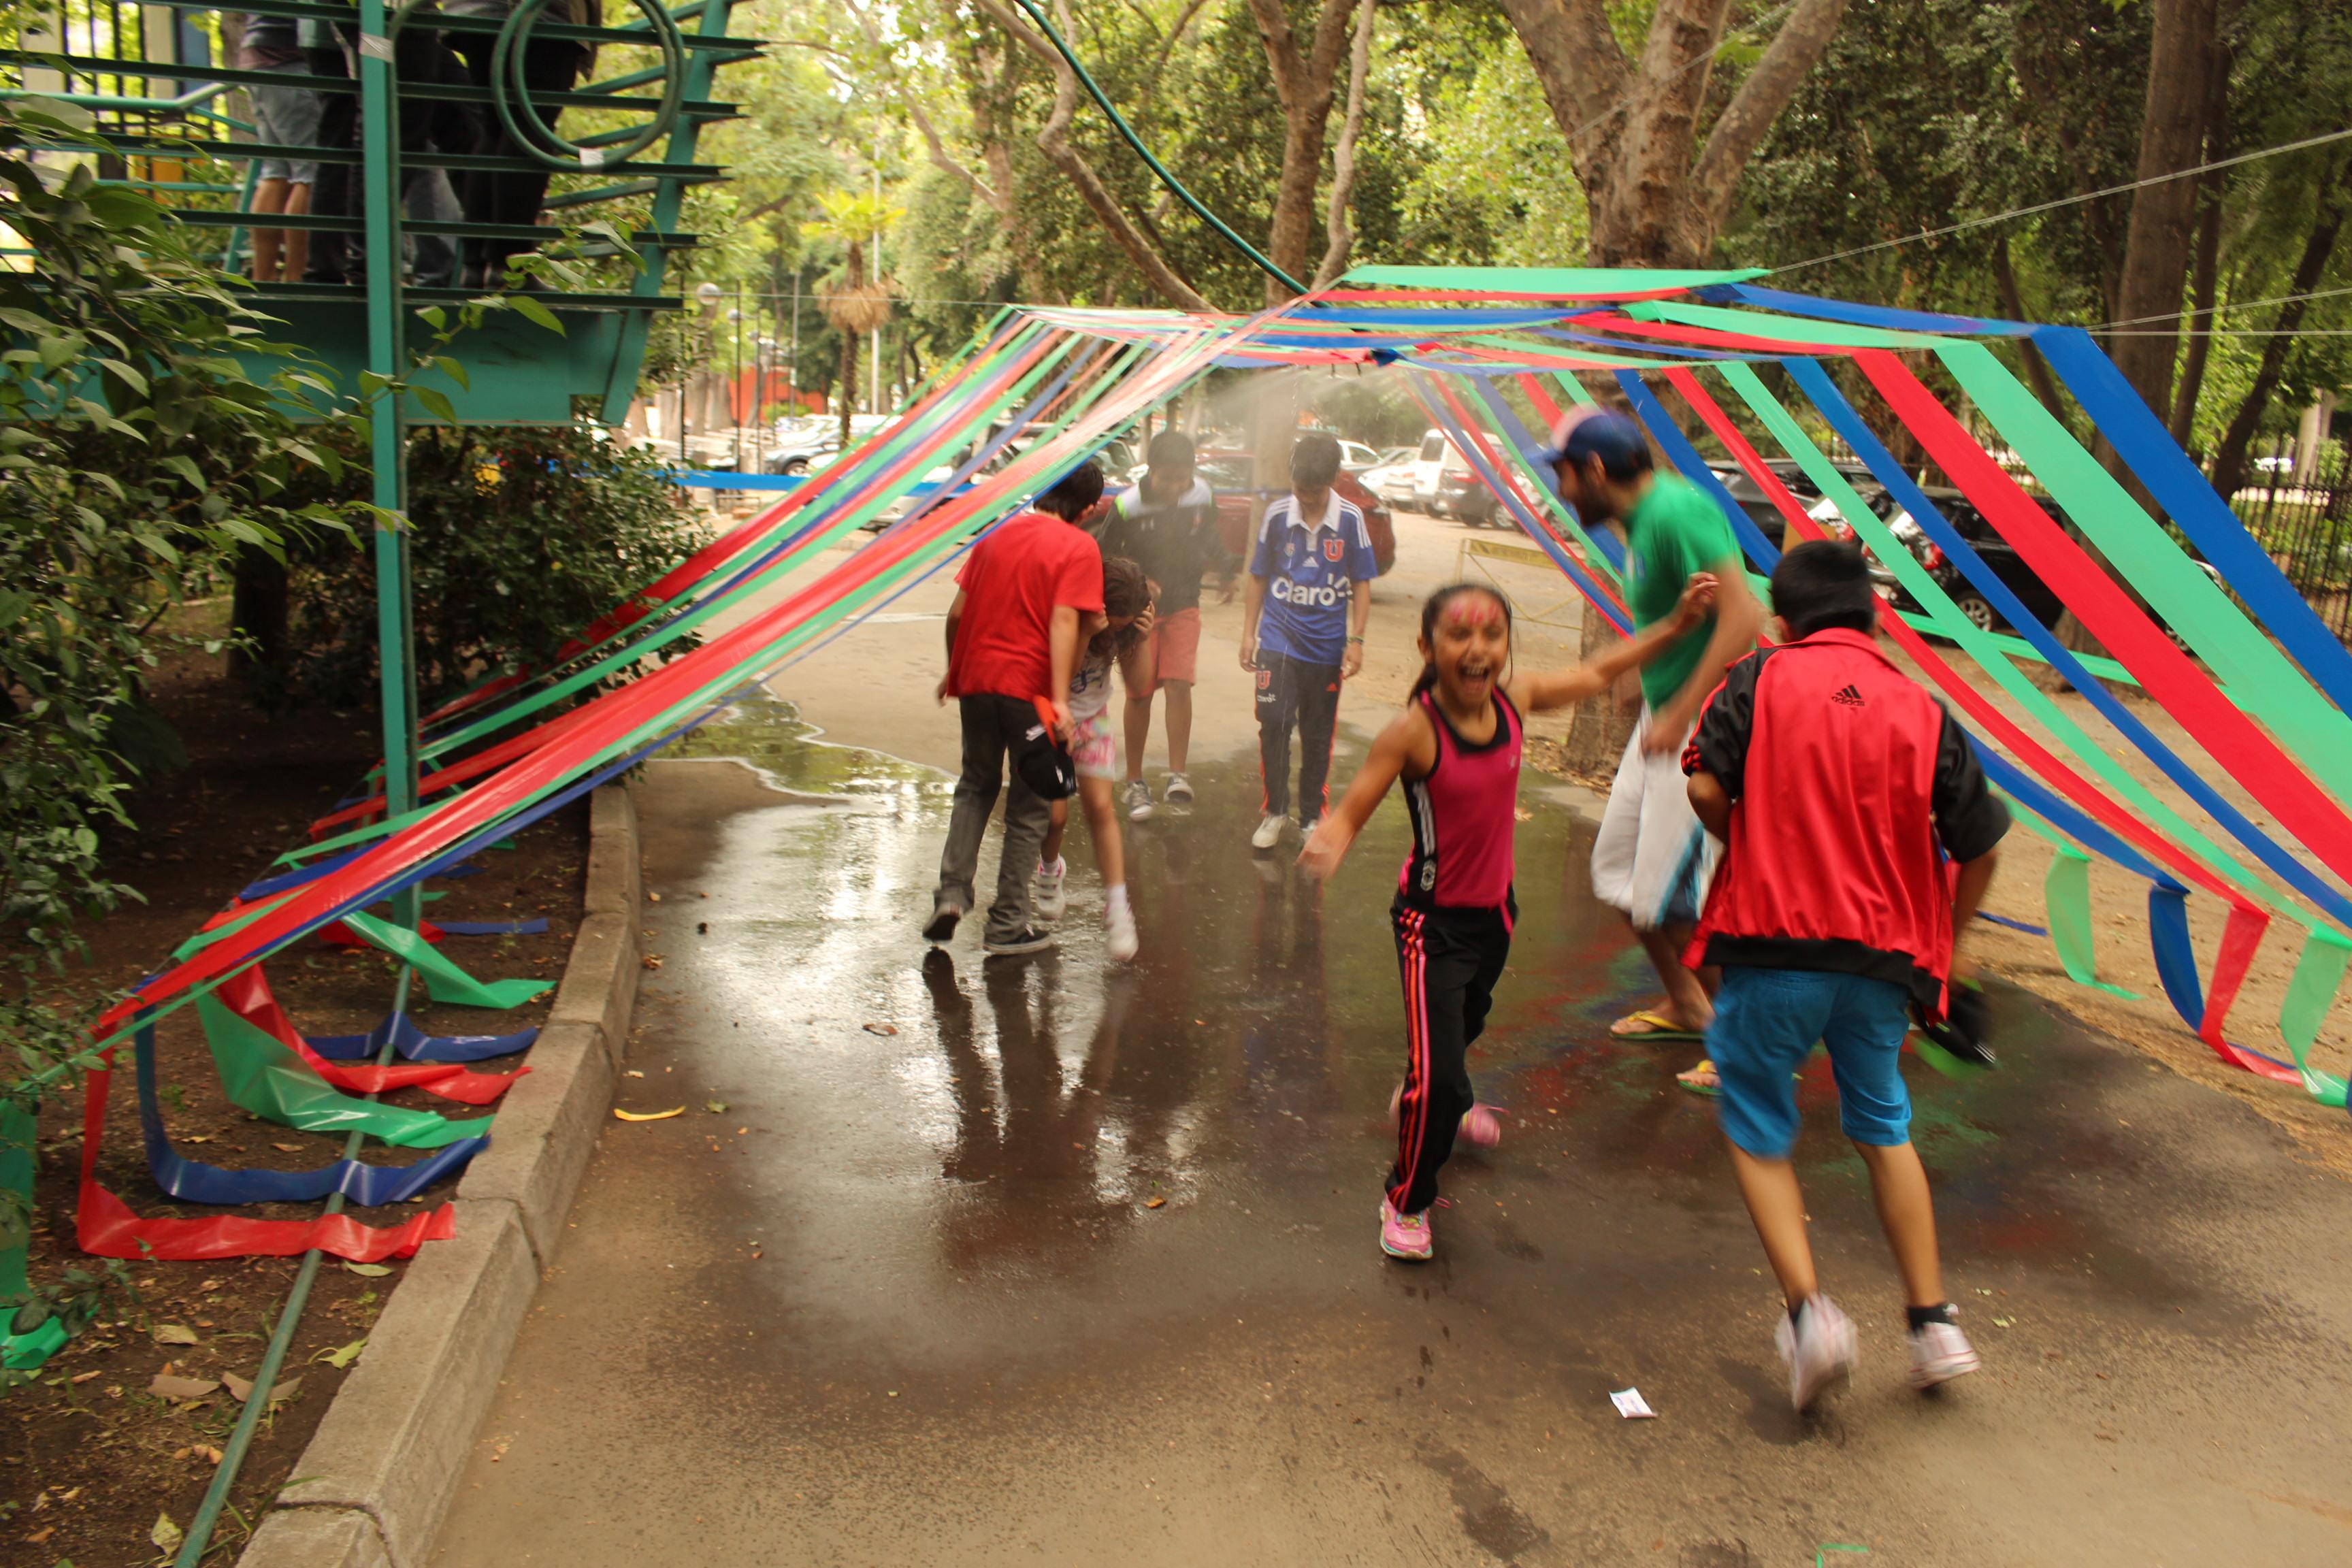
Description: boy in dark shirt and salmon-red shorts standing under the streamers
xmin=1103 ymin=430 xmax=1235 ymax=823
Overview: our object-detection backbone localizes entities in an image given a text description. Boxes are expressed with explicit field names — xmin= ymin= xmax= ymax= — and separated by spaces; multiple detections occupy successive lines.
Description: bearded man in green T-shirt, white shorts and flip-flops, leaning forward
xmin=1546 ymin=409 xmax=1764 ymax=1093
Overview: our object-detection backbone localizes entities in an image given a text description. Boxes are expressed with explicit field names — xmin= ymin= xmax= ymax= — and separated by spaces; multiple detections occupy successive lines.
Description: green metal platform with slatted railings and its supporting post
xmin=0 ymin=0 xmax=760 ymax=813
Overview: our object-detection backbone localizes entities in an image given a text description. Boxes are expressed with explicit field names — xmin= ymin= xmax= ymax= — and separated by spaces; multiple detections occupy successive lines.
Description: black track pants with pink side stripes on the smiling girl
xmin=1388 ymin=898 xmax=1510 ymax=1213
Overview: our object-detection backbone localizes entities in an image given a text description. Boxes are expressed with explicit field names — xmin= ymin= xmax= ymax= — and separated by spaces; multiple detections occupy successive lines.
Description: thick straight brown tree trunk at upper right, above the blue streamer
xmin=2110 ymin=0 xmax=2220 ymax=419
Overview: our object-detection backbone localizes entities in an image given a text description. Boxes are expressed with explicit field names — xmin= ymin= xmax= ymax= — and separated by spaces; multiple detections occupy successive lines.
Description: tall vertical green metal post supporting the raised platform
xmin=360 ymin=0 xmax=416 ymax=924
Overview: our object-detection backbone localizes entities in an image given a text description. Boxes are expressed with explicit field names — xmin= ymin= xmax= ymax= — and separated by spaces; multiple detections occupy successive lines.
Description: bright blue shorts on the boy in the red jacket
xmin=1708 ymin=966 xmax=1910 ymax=1159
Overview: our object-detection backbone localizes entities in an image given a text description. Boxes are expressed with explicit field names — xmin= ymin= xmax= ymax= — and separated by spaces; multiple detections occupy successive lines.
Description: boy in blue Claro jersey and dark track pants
xmin=1242 ymin=433 xmax=1381 ymax=849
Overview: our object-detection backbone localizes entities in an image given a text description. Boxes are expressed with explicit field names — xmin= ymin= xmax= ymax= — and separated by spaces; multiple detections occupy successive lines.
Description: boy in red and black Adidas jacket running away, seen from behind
xmin=1682 ymin=540 xmax=2008 ymax=1411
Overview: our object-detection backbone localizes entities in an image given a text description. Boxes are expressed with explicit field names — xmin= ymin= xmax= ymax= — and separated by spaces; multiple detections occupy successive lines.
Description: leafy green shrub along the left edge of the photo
xmin=0 ymin=101 xmax=362 ymax=1067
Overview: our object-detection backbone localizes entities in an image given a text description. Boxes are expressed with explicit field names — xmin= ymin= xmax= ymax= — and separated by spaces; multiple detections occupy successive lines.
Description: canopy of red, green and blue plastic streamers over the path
xmin=78 ymin=268 xmax=2352 ymax=1279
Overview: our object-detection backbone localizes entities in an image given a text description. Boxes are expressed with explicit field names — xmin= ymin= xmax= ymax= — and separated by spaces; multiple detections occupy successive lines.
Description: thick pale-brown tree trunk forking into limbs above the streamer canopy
xmin=1496 ymin=0 xmax=1846 ymax=265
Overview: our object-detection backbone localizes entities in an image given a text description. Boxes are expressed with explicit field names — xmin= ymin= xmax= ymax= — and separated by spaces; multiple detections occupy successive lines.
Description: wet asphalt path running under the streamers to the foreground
xmin=435 ymin=710 xmax=2352 ymax=1568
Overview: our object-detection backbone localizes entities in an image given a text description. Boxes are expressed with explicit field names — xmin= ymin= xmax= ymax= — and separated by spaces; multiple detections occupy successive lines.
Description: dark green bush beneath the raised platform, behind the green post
xmin=294 ymin=423 xmax=701 ymax=705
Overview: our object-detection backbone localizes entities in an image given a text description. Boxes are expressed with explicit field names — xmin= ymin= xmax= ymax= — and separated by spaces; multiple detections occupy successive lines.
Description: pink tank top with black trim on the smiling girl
xmin=1397 ymin=691 xmax=1522 ymax=910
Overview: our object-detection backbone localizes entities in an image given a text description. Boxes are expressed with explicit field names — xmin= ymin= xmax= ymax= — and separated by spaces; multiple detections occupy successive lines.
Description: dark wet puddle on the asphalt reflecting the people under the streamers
xmin=666 ymin=696 xmax=2121 ymax=1274
